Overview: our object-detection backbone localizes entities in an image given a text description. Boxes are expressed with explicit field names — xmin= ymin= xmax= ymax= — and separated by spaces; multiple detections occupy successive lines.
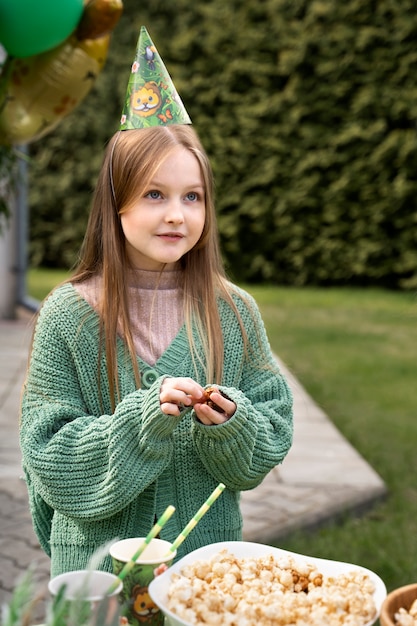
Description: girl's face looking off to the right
xmin=120 ymin=146 xmax=206 ymax=270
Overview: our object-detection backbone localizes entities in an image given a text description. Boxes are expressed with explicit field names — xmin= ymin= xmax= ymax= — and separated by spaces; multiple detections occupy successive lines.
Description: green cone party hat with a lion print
xmin=120 ymin=26 xmax=191 ymax=130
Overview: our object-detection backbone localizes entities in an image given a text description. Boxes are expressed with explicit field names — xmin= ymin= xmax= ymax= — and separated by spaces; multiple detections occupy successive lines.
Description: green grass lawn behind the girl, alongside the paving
xmin=28 ymin=270 xmax=417 ymax=590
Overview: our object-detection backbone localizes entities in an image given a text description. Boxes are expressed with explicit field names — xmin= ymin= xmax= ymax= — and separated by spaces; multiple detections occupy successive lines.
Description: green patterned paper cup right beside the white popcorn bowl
xmin=110 ymin=537 xmax=176 ymax=626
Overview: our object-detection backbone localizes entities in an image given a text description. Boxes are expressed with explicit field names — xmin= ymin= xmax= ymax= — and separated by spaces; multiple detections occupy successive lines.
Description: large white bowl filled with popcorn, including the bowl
xmin=149 ymin=541 xmax=387 ymax=626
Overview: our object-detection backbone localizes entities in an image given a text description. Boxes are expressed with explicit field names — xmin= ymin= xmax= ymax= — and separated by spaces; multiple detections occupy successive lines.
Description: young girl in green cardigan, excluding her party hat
xmin=21 ymin=124 xmax=292 ymax=576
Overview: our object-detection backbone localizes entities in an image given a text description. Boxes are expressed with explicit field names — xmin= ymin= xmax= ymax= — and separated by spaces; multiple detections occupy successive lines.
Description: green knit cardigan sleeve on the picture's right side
xmin=189 ymin=290 xmax=293 ymax=491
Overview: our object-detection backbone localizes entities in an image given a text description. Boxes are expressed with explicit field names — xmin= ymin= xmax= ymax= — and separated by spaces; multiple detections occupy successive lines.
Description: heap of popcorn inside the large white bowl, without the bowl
xmin=168 ymin=549 xmax=376 ymax=626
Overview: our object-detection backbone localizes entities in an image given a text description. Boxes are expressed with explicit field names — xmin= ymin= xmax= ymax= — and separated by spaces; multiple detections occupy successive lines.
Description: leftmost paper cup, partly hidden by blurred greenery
xmin=48 ymin=570 xmax=123 ymax=620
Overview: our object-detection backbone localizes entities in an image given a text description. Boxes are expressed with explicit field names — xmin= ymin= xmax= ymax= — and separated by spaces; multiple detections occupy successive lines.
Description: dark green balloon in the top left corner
xmin=0 ymin=0 xmax=84 ymax=58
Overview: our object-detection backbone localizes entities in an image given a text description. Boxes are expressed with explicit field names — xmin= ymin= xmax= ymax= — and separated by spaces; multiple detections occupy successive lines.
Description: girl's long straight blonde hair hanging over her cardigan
xmin=70 ymin=125 xmax=246 ymax=409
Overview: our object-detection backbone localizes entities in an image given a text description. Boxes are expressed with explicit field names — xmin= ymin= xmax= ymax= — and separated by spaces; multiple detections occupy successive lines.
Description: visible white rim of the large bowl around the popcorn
xmin=149 ymin=541 xmax=387 ymax=626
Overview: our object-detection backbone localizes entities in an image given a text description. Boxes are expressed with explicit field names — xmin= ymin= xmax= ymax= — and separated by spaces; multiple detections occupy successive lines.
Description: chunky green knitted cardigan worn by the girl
xmin=20 ymin=284 xmax=293 ymax=576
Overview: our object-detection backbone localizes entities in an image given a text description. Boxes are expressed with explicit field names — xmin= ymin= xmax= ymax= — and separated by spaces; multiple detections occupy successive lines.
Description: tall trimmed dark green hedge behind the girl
xmin=30 ymin=0 xmax=417 ymax=288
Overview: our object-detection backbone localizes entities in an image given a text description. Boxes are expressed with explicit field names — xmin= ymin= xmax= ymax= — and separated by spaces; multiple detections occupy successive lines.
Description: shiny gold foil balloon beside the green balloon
xmin=0 ymin=0 xmax=123 ymax=145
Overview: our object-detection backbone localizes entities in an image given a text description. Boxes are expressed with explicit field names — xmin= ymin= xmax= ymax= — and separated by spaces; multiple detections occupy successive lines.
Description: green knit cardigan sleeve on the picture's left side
xmin=20 ymin=288 xmax=180 ymax=520
